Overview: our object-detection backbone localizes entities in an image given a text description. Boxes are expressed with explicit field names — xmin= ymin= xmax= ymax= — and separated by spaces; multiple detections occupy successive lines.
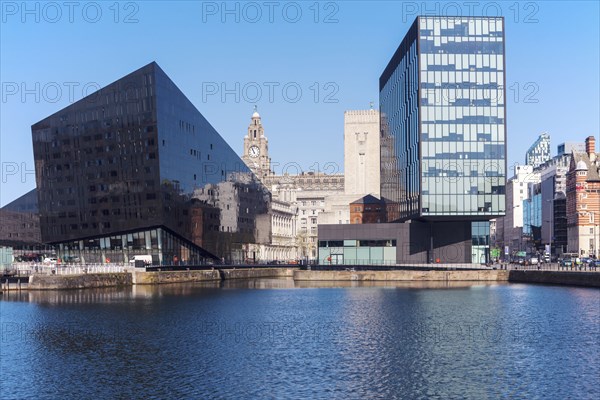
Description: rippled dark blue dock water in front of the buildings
xmin=0 ymin=280 xmax=600 ymax=399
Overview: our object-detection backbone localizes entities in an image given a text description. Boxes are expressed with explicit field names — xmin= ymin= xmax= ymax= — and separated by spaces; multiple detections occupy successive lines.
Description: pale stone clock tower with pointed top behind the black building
xmin=242 ymin=106 xmax=271 ymax=178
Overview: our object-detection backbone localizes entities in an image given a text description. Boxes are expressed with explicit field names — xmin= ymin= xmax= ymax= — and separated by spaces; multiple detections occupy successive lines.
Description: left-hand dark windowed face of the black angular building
xmin=31 ymin=63 xmax=161 ymax=243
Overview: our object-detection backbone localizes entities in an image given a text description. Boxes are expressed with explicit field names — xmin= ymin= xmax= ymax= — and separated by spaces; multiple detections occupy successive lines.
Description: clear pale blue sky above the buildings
xmin=0 ymin=1 xmax=600 ymax=205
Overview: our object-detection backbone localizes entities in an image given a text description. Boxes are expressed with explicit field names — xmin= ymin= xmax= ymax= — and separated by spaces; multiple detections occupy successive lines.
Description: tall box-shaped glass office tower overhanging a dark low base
xmin=379 ymin=17 xmax=506 ymax=221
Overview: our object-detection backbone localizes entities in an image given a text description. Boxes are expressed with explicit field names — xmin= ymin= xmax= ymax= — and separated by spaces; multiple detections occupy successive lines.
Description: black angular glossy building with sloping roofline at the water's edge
xmin=31 ymin=62 xmax=270 ymax=264
